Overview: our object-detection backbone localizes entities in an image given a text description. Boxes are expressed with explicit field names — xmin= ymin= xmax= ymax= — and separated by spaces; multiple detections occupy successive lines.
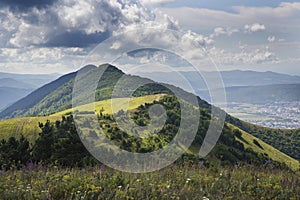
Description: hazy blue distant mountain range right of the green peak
xmin=139 ymin=70 xmax=300 ymax=104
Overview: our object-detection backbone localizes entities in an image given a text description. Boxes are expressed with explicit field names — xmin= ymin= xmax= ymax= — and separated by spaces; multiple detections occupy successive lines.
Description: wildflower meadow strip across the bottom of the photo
xmin=0 ymin=163 xmax=300 ymax=200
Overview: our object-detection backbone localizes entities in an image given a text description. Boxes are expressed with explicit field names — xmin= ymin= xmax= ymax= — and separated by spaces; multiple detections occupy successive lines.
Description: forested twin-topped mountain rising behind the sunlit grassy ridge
xmin=0 ymin=65 xmax=209 ymax=119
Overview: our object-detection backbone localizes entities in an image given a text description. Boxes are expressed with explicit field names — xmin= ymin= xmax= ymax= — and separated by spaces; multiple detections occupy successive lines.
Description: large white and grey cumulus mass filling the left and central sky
xmin=0 ymin=0 xmax=214 ymax=72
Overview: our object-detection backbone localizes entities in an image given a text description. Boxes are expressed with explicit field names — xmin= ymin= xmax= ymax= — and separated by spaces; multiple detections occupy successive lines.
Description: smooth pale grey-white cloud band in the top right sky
xmin=160 ymin=2 xmax=300 ymax=33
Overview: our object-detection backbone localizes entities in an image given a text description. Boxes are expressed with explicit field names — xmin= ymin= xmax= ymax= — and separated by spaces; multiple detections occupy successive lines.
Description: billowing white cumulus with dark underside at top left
xmin=0 ymin=0 xmax=152 ymax=47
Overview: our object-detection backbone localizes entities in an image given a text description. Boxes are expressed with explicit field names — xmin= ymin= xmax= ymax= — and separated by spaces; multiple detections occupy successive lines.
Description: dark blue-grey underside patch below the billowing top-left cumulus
xmin=46 ymin=31 xmax=110 ymax=47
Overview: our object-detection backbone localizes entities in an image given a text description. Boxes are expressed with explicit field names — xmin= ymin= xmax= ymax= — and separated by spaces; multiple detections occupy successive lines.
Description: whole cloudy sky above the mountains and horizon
xmin=0 ymin=0 xmax=300 ymax=75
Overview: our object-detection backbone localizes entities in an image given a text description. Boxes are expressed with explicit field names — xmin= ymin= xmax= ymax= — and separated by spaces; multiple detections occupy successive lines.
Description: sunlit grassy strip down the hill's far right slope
xmin=228 ymin=125 xmax=300 ymax=170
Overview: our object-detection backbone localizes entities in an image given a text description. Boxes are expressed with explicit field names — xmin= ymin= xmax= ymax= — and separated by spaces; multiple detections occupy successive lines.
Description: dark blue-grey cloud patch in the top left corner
xmin=0 ymin=0 xmax=58 ymax=11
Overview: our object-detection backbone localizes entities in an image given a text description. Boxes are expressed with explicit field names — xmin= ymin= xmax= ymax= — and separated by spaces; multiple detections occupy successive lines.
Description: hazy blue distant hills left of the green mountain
xmin=0 ymin=72 xmax=59 ymax=111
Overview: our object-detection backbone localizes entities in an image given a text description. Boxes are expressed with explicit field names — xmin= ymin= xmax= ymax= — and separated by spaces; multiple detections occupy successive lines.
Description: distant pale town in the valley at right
xmin=226 ymin=101 xmax=300 ymax=129
